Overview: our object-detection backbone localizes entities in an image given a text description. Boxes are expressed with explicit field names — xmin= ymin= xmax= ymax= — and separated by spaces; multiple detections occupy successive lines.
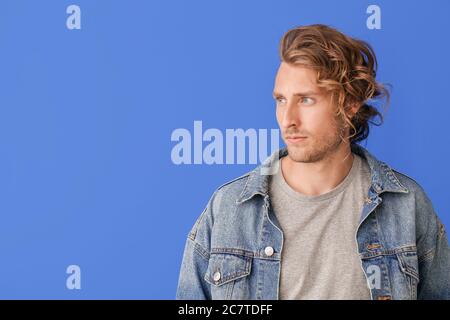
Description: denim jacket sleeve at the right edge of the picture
xmin=417 ymin=196 xmax=450 ymax=300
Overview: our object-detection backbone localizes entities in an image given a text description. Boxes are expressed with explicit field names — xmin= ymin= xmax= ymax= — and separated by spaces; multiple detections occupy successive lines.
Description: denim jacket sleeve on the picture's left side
xmin=176 ymin=195 xmax=214 ymax=300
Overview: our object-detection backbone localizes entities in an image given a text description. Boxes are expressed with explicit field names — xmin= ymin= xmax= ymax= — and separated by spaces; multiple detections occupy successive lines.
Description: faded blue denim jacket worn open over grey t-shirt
xmin=176 ymin=143 xmax=450 ymax=300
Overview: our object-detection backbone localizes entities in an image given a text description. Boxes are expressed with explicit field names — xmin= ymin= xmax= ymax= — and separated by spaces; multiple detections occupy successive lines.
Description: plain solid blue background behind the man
xmin=0 ymin=0 xmax=450 ymax=299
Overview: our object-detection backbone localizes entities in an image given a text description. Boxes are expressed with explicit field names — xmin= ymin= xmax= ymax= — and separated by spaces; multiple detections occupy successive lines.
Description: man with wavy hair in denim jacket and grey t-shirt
xmin=177 ymin=25 xmax=450 ymax=300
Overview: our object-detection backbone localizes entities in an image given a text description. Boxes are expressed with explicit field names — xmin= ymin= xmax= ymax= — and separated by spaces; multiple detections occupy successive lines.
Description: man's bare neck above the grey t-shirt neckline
xmin=281 ymin=144 xmax=354 ymax=195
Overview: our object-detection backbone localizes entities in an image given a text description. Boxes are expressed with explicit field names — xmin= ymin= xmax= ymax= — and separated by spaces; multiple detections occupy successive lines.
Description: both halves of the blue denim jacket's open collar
xmin=236 ymin=143 xmax=409 ymax=203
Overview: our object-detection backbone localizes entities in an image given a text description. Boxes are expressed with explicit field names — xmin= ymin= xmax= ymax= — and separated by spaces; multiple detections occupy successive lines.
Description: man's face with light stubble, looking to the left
xmin=274 ymin=62 xmax=344 ymax=162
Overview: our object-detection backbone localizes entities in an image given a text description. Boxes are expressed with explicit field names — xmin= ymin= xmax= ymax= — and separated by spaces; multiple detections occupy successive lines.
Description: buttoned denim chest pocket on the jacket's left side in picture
xmin=204 ymin=253 xmax=253 ymax=300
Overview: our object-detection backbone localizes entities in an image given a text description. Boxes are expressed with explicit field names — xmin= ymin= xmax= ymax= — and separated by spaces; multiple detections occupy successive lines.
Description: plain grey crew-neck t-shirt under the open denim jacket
xmin=269 ymin=153 xmax=370 ymax=300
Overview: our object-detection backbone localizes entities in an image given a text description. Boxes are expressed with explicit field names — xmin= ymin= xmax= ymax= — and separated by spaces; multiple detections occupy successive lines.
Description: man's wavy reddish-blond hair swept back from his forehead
xmin=279 ymin=24 xmax=390 ymax=142
